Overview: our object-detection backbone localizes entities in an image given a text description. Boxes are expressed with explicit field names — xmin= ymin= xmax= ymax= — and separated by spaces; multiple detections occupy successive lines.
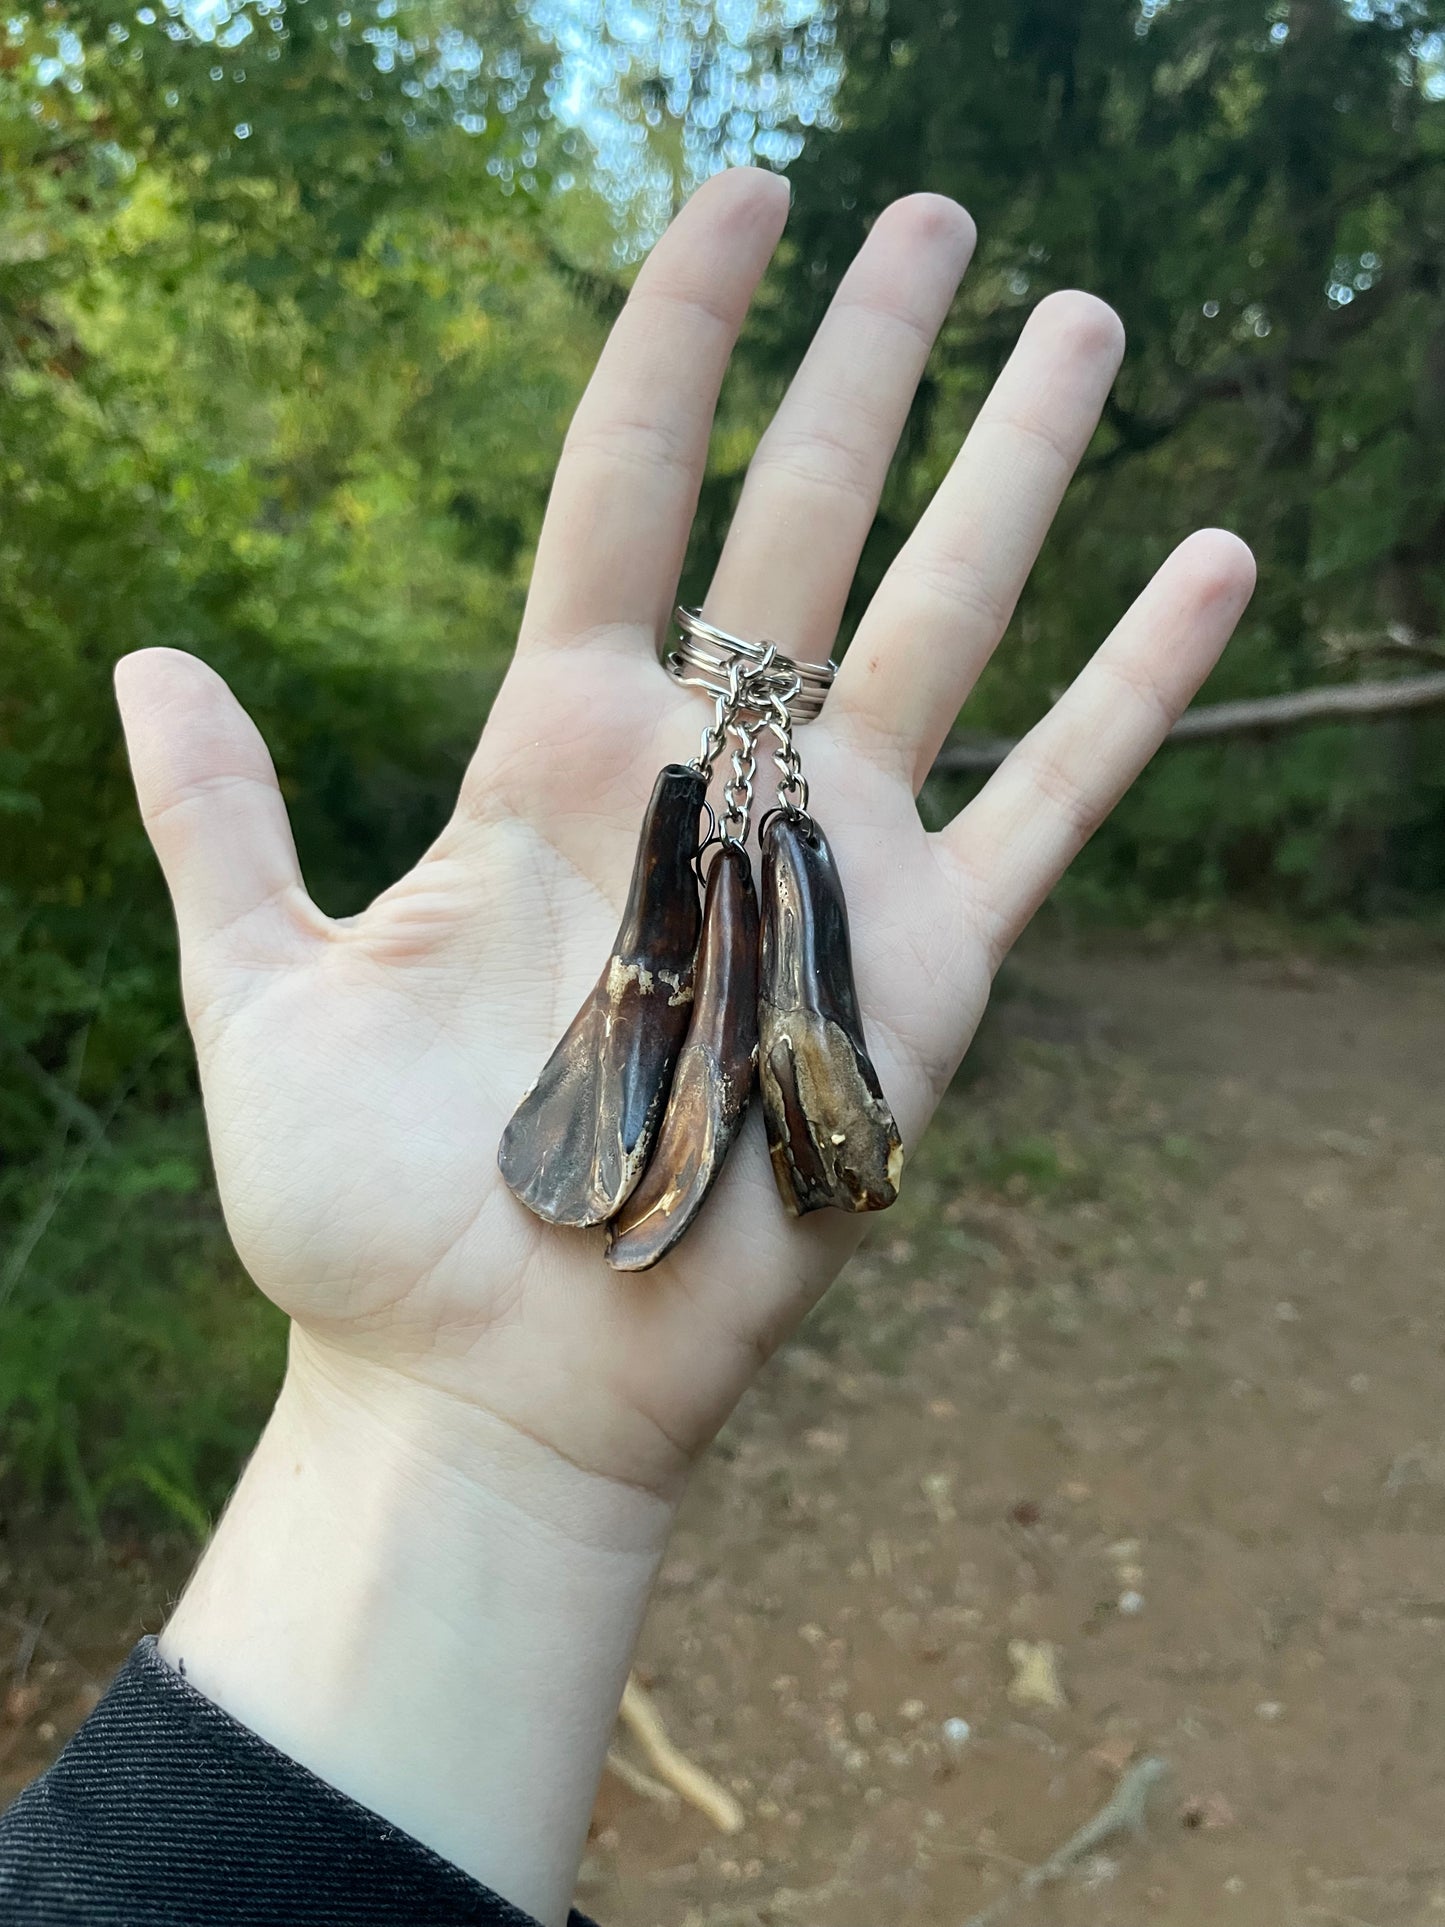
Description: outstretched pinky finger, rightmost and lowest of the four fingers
xmin=942 ymin=528 xmax=1254 ymax=964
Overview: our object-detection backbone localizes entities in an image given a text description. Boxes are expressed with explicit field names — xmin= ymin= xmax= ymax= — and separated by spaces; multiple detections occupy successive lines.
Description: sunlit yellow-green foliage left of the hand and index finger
xmin=0 ymin=6 xmax=601 ymax=1526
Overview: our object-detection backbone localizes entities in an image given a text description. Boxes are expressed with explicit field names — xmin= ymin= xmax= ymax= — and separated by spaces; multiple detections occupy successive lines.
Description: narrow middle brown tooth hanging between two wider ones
xmin=607 ymin=844 xmax=757 ymax=1272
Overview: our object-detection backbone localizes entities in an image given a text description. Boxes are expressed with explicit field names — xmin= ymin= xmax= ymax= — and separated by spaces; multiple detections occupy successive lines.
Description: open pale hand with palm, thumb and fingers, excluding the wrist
xmin=121 ymin=175 xmax=1248 ymax=1490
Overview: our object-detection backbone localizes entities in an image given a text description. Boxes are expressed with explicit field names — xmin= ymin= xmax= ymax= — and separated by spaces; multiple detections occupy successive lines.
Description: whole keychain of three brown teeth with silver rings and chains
xmin=497 ymin=607 xmax=904 ymax=1272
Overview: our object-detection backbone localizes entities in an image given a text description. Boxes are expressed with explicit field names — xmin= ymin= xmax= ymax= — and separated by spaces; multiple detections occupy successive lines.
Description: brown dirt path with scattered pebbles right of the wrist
xmin=0 ymin=946 xmax=1445 ymax=1927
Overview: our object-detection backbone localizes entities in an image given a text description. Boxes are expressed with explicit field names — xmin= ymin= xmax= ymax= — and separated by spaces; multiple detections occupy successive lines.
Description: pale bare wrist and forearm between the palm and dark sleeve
xmin=160 ymin=1335 xmax=670 ymax=1927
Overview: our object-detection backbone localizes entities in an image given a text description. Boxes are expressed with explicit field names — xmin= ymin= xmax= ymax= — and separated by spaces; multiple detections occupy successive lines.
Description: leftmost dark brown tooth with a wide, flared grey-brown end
xmin=497 ymin=763 xmax=707 ymax=1226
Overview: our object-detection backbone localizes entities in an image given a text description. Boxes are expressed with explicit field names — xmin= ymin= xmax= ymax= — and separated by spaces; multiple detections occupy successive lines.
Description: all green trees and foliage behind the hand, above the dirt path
xmin=0 ymin=0 xmax=1445 ymax=1530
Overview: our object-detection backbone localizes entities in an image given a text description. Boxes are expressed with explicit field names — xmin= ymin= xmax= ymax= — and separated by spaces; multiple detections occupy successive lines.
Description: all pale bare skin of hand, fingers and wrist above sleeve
xmin=118 ymin=170 xmax=1254 ymax=1927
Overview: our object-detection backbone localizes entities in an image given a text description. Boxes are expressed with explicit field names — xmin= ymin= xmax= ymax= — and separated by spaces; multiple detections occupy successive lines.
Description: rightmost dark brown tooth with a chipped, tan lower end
xmin=757 ymin=813 xmax=904 ymax=1216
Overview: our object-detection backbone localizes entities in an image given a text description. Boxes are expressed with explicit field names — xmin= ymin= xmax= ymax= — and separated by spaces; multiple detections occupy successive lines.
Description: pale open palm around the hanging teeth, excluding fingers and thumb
xmin=183 ymin=647 xmax=974 ymax=1484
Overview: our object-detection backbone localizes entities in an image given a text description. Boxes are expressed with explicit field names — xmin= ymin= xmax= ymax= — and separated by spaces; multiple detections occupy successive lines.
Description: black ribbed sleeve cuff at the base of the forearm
xmin=0 ymin=1640 xmax=590 ymax=1927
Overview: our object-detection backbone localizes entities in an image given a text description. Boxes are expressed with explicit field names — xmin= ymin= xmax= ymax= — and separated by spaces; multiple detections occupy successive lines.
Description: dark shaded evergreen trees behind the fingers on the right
xmin=747 ymin=0 xmax=1445 ymax=913
